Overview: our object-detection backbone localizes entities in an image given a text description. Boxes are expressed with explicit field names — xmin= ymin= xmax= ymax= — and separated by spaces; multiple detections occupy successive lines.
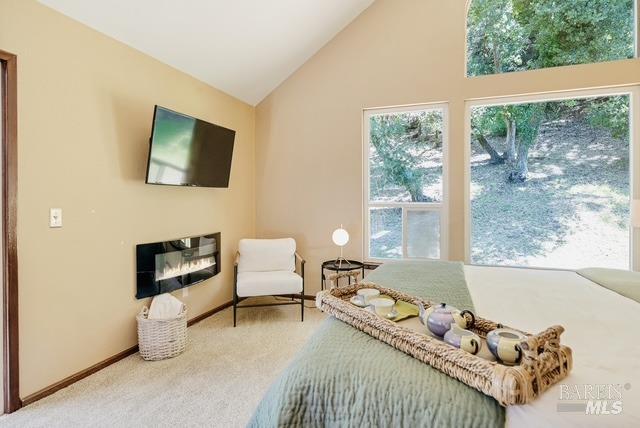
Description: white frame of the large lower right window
xmin=464 ymin=85 xmax=640 ymax=271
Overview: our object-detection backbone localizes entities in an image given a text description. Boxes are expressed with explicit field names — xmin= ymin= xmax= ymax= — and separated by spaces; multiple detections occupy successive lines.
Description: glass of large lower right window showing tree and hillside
xmin=469 ymin=92 xmax=637 ymax=269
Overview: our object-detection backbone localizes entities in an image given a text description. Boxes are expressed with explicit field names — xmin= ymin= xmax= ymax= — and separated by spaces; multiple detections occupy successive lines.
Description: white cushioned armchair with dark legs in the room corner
xmin=233 ymin=238 xmax=305 ymax=327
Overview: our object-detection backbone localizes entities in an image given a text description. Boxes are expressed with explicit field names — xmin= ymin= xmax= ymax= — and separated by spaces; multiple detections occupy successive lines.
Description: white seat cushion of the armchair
xmin=237 ymin=271 xmax=302 ymax=297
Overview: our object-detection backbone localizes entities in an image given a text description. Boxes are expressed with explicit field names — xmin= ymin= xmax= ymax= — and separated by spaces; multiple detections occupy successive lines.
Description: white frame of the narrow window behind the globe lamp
xmin=362 ymin=102 xmax=449 ymax=263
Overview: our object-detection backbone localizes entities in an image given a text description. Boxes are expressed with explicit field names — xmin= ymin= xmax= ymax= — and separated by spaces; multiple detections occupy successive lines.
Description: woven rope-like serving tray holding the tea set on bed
xmin=316 ymin=283 xmax=573 ymax=406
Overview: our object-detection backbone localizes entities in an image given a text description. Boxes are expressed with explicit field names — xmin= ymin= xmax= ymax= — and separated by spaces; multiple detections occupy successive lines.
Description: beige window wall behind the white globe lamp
xmin=256 ymin=0 xmax=640 ymax=291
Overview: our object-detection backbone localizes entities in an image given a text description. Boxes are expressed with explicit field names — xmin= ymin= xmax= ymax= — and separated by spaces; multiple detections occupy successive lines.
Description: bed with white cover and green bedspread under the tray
xmin=250 ymin=262 xmax=640 ymax=427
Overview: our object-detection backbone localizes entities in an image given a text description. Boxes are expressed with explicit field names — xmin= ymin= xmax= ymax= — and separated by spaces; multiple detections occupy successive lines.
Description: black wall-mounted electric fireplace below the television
xmin=136 ymin=233 xmax=220 ymax=299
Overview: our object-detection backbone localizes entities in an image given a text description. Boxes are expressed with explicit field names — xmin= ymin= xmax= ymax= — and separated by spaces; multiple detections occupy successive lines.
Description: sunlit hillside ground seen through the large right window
xmin=471 ymin=97 xmax=630 ymax=269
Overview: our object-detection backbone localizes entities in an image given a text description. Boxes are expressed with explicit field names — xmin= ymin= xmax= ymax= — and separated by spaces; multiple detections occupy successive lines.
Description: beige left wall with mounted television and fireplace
xmin=0 ymin=0 xmax=255 ymax=397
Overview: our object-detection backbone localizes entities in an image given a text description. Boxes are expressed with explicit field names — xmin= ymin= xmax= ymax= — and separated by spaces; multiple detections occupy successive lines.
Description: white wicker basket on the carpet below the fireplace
xmin=136 ymin=305 xmax=187 ymax=361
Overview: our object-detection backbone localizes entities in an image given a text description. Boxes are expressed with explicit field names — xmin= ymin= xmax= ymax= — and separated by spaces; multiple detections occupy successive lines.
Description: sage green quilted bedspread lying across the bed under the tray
xmin=249 ymin=261 xmax=505 ymax=427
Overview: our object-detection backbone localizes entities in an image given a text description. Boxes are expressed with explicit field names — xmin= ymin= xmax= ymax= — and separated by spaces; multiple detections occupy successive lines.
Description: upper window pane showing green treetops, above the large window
xmin=467 ymin=0 xmax=637 ymax=76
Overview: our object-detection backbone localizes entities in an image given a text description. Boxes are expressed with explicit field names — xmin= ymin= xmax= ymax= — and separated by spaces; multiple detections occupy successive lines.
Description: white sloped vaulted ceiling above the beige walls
xmin=40 ymin=0 xmax=374 ymax=105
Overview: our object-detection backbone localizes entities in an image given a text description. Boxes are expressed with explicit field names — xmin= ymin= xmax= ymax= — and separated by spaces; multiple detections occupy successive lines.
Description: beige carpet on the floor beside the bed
xmin=0 ymin=302 xmax=325 ymax=427
